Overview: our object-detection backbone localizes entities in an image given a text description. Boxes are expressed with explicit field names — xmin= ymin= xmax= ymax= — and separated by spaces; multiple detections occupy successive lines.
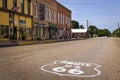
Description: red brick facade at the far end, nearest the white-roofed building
xmin=57 ymin=2 xmax=71 ymax=39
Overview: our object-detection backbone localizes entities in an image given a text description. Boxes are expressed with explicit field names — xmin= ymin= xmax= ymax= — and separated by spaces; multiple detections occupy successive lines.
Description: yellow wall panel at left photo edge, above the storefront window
xmin=0 ymin=12 xmax=9 ymax=26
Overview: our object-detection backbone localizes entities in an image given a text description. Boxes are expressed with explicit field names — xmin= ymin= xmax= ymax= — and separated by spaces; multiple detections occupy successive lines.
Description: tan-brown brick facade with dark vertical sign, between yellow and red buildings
xmin=33 ymin=0 xmax=57 ymax=39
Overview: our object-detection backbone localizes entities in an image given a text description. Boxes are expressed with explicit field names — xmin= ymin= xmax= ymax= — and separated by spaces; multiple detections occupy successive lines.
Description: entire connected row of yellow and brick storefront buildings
xmin=0 ymin=0 xmax=71 ymax=40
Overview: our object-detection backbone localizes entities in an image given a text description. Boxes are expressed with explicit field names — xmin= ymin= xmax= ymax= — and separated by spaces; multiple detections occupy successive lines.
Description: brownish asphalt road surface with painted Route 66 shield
xmin=0 ymin=38 xmax=120 ymax=80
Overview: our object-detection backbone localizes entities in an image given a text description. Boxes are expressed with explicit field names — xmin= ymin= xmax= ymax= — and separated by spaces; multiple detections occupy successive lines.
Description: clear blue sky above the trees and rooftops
xmin=57 ymin=0 xmax=120 ymax=32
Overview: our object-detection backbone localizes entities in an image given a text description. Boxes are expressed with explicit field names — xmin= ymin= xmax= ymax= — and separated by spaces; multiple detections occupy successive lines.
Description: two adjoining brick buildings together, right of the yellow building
xmin=33 ymin=0 xmax=71 ymax=39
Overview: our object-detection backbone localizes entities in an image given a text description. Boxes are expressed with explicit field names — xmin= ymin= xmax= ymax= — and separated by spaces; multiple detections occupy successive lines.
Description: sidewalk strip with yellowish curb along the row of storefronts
xmin=0 ymin=39 xmax=76 ymax=48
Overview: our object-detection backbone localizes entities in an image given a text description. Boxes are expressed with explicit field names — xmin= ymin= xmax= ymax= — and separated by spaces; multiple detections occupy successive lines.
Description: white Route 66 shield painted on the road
xmin=41 ymin=60 xmax=101 ymax=77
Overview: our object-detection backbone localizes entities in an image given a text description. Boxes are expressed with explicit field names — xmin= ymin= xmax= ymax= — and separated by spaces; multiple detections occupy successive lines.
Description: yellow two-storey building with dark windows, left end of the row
xmin=0 ymin=0 xmax=33 ymax=40
